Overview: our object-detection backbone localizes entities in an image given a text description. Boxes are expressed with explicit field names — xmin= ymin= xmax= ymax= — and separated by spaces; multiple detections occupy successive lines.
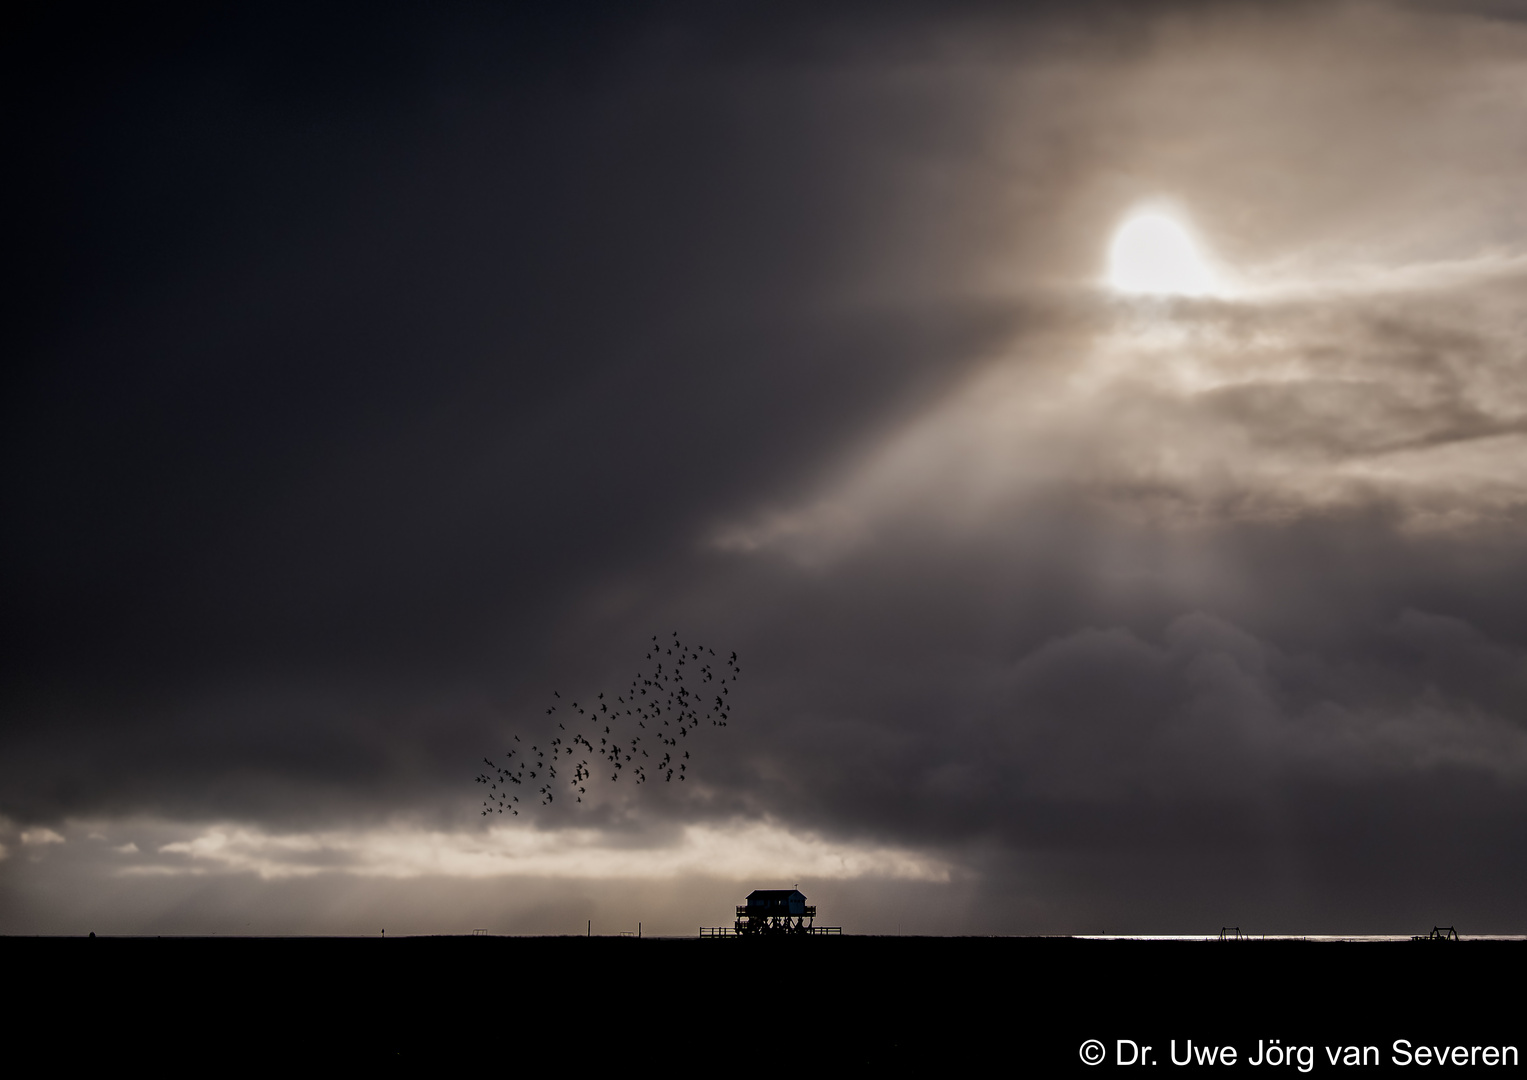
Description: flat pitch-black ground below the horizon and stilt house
xmin=0 ymin=936 xmax=1527 ymax=1077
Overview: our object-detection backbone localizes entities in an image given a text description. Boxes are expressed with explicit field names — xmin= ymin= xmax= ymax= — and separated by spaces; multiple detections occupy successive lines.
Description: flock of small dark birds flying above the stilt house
xmin=473 ymin=631 xmax=742 ymax=817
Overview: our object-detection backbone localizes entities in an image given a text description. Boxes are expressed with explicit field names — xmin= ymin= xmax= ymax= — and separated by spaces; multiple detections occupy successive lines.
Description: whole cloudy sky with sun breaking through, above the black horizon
xmin=0 ymin=3 xmax=1527 ymax=933
